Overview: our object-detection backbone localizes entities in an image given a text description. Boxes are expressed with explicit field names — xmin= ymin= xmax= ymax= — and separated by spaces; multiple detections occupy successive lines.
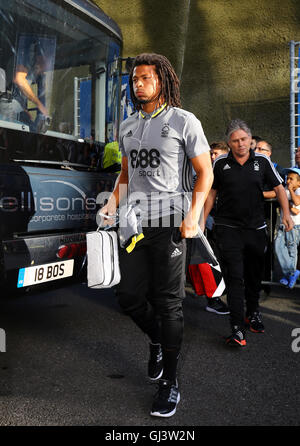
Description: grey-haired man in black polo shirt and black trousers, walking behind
xmin=204 ymin=119 xmax=293 ymax=347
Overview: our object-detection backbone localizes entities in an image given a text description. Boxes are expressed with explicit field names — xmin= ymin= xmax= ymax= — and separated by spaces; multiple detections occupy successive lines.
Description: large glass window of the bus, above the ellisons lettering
xmin=0 ymin=0 xmax=120 ymax=166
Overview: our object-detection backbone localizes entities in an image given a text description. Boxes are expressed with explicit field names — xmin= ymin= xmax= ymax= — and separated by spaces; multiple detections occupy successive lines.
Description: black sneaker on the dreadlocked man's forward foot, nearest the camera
xmin=150 ymin=379 xmax=180 ymax=417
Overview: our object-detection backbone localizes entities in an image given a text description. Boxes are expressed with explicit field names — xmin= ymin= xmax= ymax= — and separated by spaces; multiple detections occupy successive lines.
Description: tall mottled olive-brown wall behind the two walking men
xmin=95 ymin=0 xmax=300 ymax=165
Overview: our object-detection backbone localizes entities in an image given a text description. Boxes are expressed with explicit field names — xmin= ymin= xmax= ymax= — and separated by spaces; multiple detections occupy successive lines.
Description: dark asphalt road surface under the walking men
xmin=0 ymin=278 xmax=300 ymax=428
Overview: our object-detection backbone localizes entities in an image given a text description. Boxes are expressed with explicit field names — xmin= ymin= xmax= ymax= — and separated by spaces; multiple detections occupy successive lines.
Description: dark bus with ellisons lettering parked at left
xmin=0 ymin=0 xmax=127 ymax=290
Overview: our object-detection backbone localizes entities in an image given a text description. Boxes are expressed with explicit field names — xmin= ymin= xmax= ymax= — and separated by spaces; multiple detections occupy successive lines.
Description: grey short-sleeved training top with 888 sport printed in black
xmin=119 ymin=105 xmax=210 ymax=220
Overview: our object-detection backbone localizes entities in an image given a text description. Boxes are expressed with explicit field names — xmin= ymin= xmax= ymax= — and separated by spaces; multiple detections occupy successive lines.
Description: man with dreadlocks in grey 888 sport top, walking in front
xmin=101 ymin=54 xmax=213 ymax=417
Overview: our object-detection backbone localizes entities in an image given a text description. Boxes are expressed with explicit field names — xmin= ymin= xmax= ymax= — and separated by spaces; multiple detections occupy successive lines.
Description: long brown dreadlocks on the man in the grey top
xmin=129 ymin=53 xmax=181 ymax=110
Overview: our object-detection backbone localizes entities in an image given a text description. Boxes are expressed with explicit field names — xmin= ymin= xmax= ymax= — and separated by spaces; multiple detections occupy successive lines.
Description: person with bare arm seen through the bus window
xmin=1 ymin=44 xmax=49 ymax=131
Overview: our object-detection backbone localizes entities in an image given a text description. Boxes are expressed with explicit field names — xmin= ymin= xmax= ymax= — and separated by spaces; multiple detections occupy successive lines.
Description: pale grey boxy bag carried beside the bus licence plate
xmin=86 ymin=228 xmax=121 ymax=288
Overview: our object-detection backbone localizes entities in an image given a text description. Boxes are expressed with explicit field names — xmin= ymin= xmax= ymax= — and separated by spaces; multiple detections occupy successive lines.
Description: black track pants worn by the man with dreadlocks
xmin=117 ymin=228 xmax=186 ymax=351
